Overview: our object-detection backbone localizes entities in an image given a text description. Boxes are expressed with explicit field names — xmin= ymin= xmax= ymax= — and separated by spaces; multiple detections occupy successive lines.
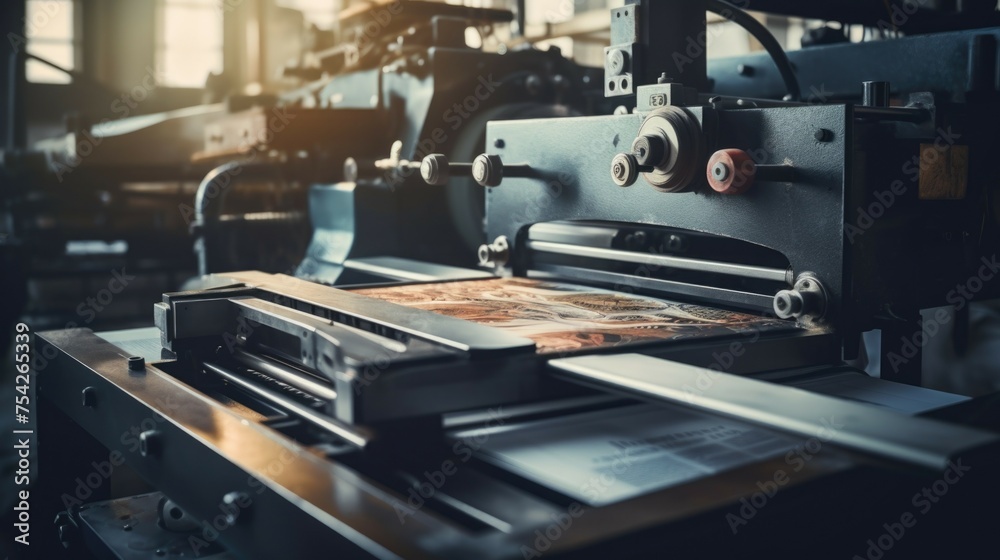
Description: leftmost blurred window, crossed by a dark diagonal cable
xmin=24 ymin=0 xmax=77 ymax=84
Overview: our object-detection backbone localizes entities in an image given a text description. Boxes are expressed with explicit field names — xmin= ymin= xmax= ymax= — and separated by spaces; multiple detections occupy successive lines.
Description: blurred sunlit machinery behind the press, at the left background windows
xmin=4 ymin=2 xmax=602 ymax=336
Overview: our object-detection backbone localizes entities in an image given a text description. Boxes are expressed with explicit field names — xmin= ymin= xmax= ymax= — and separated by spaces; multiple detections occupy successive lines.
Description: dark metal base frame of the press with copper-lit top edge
xmin=38 ymin=330 xmax=995 ymax=558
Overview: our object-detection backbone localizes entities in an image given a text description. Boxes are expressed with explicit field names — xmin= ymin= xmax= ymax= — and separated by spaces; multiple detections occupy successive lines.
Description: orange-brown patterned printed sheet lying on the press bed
xmin=354 ymin=278 xmax=796 ymax=353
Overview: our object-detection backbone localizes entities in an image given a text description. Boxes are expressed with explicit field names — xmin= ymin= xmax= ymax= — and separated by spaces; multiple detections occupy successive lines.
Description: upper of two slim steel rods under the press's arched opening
xmin=528 ymin=241 xmax=788 ymax=283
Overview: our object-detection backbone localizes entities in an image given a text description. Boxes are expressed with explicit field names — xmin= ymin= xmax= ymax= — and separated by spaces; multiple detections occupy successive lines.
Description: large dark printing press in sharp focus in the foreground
xmin=25 ymin=1 xmax=1000 ymax=558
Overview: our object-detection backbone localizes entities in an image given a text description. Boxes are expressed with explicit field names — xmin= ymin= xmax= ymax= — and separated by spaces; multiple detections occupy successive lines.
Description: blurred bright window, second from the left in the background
xmin=156 ymin=0 xmax=226 ymax=88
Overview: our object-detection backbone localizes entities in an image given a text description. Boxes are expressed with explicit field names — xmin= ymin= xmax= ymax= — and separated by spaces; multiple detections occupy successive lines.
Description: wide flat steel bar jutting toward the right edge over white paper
xmin=549 ymin=354 xmax=1000 ymax=471
